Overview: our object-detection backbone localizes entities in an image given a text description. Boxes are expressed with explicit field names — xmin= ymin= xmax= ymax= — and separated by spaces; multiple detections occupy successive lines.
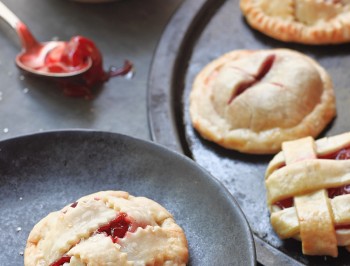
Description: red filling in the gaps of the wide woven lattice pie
xmin=274 ymin=147 xmax=350 ymax=212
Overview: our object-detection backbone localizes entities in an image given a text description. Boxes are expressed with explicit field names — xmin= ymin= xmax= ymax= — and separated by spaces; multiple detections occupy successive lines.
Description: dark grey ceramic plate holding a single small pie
xmin=0 ymin=131 xmax=256 ymax=265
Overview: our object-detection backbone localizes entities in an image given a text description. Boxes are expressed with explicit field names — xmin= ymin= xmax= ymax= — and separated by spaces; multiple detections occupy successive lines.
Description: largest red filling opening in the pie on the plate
xmin=97 ymin=213 xmax=131 ymax=243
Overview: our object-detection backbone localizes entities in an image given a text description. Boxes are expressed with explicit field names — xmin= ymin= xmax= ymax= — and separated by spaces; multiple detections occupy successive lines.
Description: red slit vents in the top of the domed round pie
xmin=227 ymin=54 xmax=280 ymax=104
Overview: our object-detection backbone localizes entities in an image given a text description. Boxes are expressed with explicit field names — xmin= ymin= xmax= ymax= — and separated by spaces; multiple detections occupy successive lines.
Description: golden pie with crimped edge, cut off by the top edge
xmin=240 ymin=0 xmax=350 ymax=44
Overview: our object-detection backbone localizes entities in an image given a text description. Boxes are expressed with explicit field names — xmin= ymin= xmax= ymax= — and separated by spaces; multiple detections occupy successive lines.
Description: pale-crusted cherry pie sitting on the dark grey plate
xmin=24 ymin=191 xmax=188 ymax=266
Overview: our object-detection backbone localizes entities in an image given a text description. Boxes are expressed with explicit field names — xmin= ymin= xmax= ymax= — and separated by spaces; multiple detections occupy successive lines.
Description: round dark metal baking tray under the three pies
xmin=148 ymin=0 xmax=350 ymax=265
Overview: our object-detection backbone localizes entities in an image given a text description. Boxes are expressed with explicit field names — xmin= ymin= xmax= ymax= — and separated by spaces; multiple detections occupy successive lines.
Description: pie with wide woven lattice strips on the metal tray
xmin=266 ymin=133 xmax=350 ymax=257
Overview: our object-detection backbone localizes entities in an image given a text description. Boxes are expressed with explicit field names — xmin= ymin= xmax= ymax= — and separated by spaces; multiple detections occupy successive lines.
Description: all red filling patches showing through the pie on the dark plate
xmin=50 ymin=211 xmax=132 ymax=266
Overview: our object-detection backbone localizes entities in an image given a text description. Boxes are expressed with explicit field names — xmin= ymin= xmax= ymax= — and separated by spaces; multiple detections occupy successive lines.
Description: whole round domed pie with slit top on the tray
xmin=190 ymin=49 xmax=335 ymax=153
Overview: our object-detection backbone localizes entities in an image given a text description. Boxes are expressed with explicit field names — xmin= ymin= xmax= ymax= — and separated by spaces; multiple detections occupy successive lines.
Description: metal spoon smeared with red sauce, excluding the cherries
xmin=0 ymin=1 xmax=92 ymax=78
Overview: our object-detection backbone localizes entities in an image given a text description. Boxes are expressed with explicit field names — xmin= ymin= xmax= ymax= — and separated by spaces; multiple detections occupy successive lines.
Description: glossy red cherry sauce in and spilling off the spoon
xmin=17 ymin=23 xmax=133 ymax=98
